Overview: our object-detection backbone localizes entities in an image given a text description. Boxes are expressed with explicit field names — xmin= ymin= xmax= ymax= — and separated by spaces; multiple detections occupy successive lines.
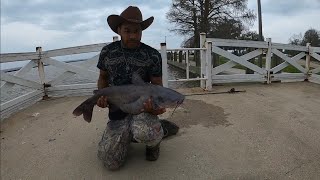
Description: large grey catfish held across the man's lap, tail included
xmin=73 ymin=73 xmax=184 ymax=122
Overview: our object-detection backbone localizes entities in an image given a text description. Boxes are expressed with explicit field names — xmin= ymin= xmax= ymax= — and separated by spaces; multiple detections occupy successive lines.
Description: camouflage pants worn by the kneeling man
xmin=98 ymin=113 xmax=163 ymax=170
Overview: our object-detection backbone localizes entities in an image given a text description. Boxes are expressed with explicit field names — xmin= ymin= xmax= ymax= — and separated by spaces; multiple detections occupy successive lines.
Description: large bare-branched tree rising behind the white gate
xmin=167 ymin=0 xmax=255 ymax=47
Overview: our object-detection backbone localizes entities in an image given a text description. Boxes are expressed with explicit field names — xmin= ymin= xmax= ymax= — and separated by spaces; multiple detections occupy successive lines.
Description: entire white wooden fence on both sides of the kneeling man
xmin=0 ymin=33 xmax=320 ymax=120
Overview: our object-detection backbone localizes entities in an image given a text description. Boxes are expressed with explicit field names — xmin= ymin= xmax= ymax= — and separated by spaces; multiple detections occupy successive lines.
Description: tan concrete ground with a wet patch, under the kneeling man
xmin=1 ymin=82 xmax=320 ymax=180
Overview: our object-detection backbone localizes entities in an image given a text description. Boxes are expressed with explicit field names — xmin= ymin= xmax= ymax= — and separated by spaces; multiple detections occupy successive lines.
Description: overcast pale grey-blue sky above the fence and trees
xmin=1 ymin=0 xmax=320 ymax=53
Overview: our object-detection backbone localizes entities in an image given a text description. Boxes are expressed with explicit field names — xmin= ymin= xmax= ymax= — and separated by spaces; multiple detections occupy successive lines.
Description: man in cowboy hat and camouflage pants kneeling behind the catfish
xmin=97 ymin=6 xmax=179 ymax=170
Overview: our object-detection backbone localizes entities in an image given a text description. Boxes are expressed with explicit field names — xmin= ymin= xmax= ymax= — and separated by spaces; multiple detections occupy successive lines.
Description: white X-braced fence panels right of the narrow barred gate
xmin=206 ymin=38 xmax=320 ymax=83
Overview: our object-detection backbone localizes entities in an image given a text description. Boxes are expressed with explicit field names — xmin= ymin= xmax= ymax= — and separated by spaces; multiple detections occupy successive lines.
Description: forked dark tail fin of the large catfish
xmin=72 ymin=96 xmax=99 ymax=123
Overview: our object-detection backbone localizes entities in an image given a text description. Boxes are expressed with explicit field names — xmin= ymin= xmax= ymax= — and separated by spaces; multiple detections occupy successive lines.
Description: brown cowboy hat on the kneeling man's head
xmin=107 ymin=6 xmax=154 ymax=34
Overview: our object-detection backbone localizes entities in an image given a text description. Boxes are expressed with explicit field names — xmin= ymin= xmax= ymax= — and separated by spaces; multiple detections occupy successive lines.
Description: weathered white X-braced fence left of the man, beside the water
xmin=1 ymin=43 xmax=106 ymax=119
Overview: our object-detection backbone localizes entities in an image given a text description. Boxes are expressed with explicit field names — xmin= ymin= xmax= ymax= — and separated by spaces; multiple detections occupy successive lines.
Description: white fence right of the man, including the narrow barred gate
xmin=161 ymin=33 xmax=320 ymax=86
